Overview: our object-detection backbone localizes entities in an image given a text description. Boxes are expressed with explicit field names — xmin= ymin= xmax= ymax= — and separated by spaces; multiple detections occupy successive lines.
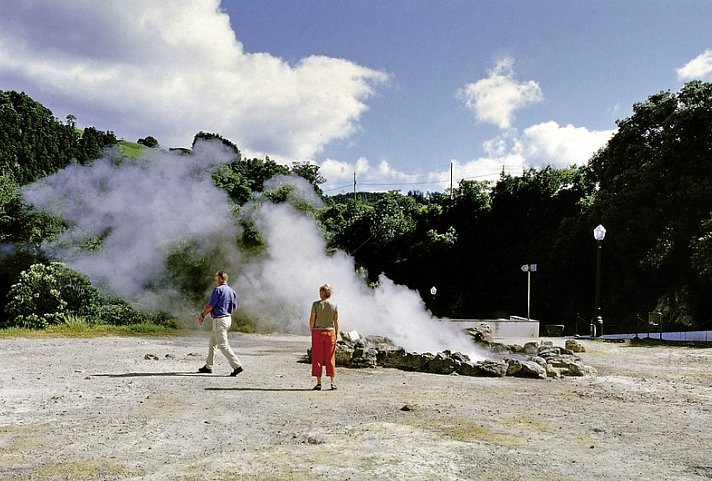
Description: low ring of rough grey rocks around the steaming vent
xmin=305 ymin=324 xmax=596 ymax=379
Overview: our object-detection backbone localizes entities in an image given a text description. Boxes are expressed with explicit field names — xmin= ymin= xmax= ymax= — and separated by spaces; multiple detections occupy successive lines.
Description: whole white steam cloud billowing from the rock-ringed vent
xmin=23 ymin=141 xmax=483 ymax=359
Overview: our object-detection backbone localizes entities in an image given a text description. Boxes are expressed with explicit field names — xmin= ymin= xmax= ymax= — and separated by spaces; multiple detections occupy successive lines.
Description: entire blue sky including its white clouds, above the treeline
xmin=0 ymin=0 xmax=712 ymax=194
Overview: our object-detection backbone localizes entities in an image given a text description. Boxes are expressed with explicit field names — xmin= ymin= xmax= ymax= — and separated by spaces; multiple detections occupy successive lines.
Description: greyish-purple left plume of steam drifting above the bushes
xmin=23 ymin=142 xmax=242 ymax=310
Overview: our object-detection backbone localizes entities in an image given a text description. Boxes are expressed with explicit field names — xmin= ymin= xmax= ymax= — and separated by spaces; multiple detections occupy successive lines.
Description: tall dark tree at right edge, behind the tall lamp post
xmin=589 ymin=81 xmax=712 ymax=328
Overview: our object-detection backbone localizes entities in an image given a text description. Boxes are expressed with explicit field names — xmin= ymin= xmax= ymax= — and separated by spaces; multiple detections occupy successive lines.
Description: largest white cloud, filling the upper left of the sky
xmin=0 ymin=0 xmax=388 ymax=159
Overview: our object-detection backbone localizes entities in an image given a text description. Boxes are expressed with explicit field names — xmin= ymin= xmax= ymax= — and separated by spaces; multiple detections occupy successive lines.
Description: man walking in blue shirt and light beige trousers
xmin=198 ymin=271 xmax=243 ymax=376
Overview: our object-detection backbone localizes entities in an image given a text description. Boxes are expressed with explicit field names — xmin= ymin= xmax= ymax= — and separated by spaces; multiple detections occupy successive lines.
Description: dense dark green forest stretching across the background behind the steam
xmin=0 ymin=81 xmax=712 ymax=334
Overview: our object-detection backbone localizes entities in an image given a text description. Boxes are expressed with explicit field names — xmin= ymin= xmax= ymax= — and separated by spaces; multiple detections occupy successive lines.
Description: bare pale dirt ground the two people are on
xmin=0 ymin=332 xmax=712 ymax=481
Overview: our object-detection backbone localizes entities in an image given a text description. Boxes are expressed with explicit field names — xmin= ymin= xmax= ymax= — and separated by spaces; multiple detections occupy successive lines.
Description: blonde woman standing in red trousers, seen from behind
xmin=309 ymin=284 xmax=339 ymax=391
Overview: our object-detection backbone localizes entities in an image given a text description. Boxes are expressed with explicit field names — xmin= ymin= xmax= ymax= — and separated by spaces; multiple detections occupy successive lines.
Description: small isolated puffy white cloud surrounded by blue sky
xmin=458 ymin=58 xmax=544 ymax=129
